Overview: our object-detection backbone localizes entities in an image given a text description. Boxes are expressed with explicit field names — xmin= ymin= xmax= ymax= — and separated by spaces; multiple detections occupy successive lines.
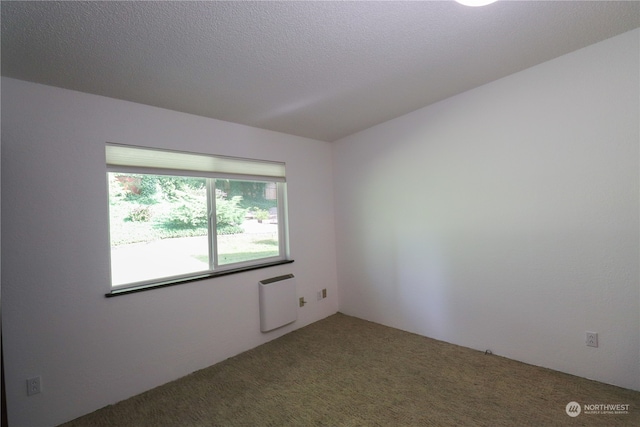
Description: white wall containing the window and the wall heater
xmin=1 ymin=78 xmax=338 ymax=426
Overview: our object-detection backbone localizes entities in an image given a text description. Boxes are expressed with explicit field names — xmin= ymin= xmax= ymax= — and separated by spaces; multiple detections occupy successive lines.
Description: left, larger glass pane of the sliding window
xmin=108 ymin=172 xmax=209 ymax=286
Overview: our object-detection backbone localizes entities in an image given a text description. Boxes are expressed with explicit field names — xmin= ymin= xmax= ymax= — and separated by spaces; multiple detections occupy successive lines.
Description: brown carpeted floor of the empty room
xmin=64 ymin=314 xmax=640 ymax=427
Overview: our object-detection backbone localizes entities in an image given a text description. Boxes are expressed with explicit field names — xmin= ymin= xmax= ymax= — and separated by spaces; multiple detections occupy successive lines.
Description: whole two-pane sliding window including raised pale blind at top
xmin=106 ymin=144 xmax=287 ymax=289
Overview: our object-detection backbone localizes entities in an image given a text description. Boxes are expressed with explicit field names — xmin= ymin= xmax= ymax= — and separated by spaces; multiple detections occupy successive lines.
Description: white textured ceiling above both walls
xmin=1 ymin=1 xmax=640 ymax=141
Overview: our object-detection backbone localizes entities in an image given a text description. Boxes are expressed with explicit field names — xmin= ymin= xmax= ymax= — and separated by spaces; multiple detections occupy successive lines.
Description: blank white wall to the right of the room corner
xmin=333 ymin=30 xmax=640 ymax=390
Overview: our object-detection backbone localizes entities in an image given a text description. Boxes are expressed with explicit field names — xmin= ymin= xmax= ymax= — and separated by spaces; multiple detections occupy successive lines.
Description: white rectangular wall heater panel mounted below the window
xmin=259 ymin=274 xmax=298 ymax=332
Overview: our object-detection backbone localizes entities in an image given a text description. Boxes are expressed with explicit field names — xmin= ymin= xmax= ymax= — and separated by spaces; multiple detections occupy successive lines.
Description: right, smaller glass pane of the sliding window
xmin=215 ymin=179 xmax=280 ymax=265
